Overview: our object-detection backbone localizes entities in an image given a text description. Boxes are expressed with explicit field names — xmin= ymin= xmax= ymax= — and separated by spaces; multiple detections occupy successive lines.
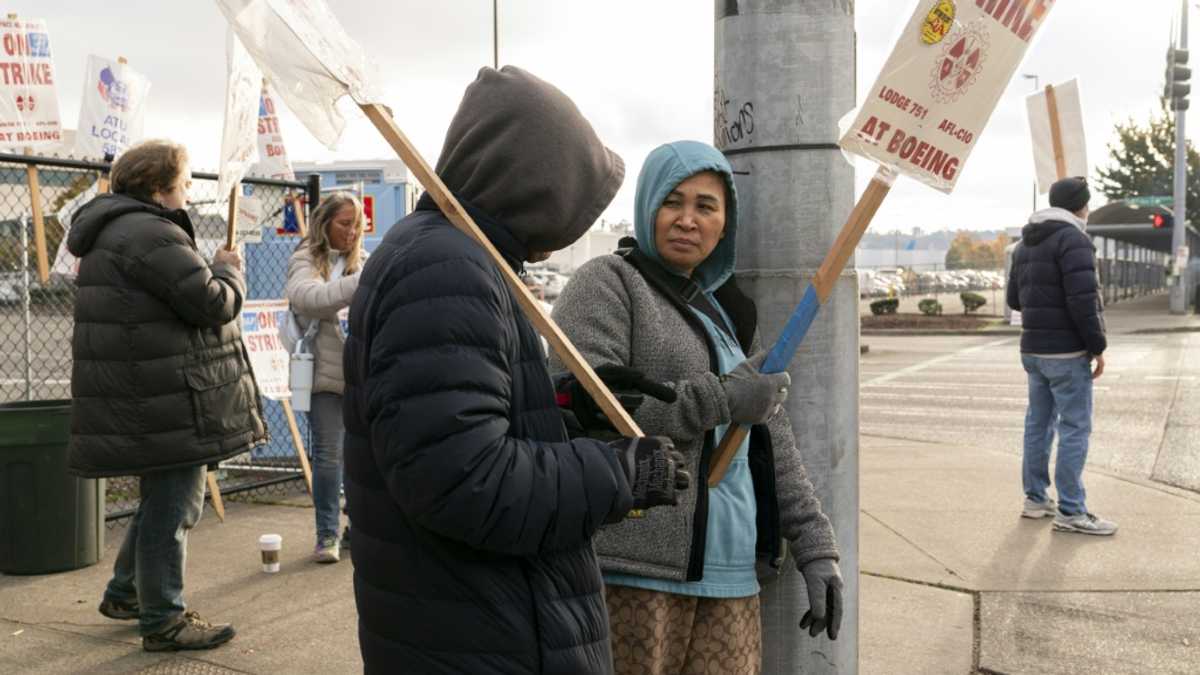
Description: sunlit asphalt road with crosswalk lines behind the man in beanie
xmin=860 ymin=333 xmax=1200 ymax=494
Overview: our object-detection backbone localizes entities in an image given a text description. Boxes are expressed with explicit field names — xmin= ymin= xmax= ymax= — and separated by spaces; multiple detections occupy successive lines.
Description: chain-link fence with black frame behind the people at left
xmin=0 ymin=154 xmax=317 ymax=526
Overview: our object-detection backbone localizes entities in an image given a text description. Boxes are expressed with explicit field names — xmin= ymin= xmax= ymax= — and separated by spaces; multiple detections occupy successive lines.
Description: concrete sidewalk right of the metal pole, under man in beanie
xmin=859 ymin=436 xmax=1200 ymax=675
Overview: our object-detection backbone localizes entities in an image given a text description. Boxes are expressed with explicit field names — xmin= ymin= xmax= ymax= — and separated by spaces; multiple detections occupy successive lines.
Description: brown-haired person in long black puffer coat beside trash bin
xmin=67 ymin=141 xmax=268 ymax=651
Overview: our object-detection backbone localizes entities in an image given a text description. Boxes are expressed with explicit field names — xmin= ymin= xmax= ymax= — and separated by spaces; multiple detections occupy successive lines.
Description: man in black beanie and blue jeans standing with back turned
xmin=1007 ymin=178 xmax=1117 ymax=534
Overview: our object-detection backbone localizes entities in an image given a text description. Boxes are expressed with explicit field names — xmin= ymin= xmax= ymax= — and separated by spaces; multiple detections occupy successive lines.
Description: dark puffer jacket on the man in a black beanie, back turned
xmin=1007 ymin=209 xmax=1108 ymax=354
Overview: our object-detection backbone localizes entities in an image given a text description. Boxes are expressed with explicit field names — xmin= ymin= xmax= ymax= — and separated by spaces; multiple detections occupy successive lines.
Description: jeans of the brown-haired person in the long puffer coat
xmin=104 ymin=466 xmax=204 ymax=635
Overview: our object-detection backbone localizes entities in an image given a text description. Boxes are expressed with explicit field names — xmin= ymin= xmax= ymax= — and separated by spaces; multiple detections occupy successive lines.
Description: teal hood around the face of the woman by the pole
xmin=634 ymin=141 xmax=738 ymax=292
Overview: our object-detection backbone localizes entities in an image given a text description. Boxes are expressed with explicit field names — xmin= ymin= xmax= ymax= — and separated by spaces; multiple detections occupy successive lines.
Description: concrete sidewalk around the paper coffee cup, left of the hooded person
xmin=0 ymin=496 xmax=362 ymax=674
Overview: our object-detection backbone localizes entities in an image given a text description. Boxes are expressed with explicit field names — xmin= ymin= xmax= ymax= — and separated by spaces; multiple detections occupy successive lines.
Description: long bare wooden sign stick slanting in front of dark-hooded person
xmin=359 ymin=103 xmax=643 ymax=436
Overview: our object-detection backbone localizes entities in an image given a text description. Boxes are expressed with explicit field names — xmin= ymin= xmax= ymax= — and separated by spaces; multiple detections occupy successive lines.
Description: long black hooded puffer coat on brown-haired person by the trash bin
xmin=67 ymin=189 xmax=266 ymax=477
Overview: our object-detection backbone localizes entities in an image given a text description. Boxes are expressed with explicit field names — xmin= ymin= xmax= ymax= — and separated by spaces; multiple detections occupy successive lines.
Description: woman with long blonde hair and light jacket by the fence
xmin=287 ymin=192 xmax=367 ymax=562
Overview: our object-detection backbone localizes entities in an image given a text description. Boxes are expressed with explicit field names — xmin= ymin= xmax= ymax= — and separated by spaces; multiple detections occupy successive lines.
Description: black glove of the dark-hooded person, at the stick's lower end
xmin=608 ymin=436 xmax=691 ymax=509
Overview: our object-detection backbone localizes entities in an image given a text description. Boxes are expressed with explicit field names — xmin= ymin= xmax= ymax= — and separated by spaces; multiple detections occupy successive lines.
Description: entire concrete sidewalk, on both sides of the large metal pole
xmin=0 ymin=427 xmax=1200 ymax=675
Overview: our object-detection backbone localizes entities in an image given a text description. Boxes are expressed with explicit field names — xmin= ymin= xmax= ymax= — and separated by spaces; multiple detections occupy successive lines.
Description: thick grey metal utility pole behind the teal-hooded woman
xmin=713 ymin=0 xmax=859 ymax=675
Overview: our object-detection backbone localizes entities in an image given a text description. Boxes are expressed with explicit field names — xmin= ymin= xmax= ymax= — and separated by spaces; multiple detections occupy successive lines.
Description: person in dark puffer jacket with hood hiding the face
xmin=344 ymin=66 xmax=685 ymax=675
